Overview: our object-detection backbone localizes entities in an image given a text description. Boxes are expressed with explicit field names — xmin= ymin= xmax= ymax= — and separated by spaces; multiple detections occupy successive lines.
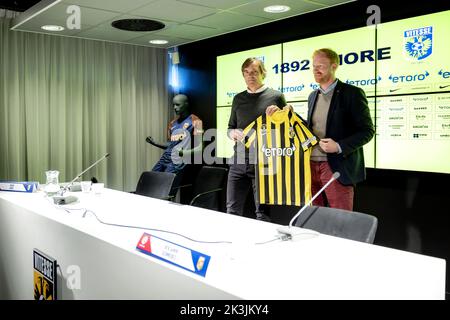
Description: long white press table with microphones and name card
xmin=0 ymin=189 xmax=446 ymax=299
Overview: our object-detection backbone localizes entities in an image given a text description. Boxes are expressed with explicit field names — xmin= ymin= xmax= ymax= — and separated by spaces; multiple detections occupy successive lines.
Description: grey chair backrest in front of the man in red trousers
xmin=295 ymin=206 xmax=378 ymax=243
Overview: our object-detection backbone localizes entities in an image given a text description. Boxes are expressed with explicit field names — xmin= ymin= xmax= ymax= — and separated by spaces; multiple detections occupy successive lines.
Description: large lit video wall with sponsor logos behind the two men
xmin=217 ymin=11 xmax=450 ymax=173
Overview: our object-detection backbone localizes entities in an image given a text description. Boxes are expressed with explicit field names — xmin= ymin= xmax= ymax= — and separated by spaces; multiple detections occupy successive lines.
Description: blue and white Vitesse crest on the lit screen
xmin=403 ymin=26 xmax=433 ymax=61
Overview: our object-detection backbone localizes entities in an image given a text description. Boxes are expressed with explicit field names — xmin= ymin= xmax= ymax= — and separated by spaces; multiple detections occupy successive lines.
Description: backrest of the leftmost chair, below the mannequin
xmin=135 ymin=171 xmax=176 ymax=200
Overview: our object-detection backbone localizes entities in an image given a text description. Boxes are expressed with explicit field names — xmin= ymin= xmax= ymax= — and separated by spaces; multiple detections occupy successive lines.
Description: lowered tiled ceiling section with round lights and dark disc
xmin=13 ymin=0 xmax=353 ymax=48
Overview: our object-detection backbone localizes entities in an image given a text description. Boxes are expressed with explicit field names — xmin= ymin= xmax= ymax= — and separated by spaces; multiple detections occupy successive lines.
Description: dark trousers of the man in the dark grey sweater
xmin=227 ymin=164 xmax=270 ymax=221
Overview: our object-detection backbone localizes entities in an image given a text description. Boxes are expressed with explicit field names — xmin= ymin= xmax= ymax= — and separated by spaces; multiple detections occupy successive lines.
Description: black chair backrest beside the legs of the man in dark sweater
xmin=190 ymin=166 xmax=228 ymax=211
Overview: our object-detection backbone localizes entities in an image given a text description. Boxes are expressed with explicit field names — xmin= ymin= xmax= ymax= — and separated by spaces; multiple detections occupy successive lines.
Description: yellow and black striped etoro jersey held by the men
xmin=243 ymin=108 xmax=318 ymax=206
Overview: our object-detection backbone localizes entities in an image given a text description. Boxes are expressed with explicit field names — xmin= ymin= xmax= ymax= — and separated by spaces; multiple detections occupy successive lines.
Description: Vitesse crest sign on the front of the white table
xmin=33 ymin=249 xmax=57 ymax=300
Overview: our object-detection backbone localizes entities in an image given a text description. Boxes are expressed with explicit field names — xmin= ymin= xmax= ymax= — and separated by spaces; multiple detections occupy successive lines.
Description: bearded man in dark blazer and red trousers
xmin=308 ymin=49 xmax=375 ymax=210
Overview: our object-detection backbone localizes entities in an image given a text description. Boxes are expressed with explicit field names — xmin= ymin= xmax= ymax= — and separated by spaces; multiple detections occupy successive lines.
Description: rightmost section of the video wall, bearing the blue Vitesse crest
xmin=376 ymin=11 xmax=450 ymax=173
